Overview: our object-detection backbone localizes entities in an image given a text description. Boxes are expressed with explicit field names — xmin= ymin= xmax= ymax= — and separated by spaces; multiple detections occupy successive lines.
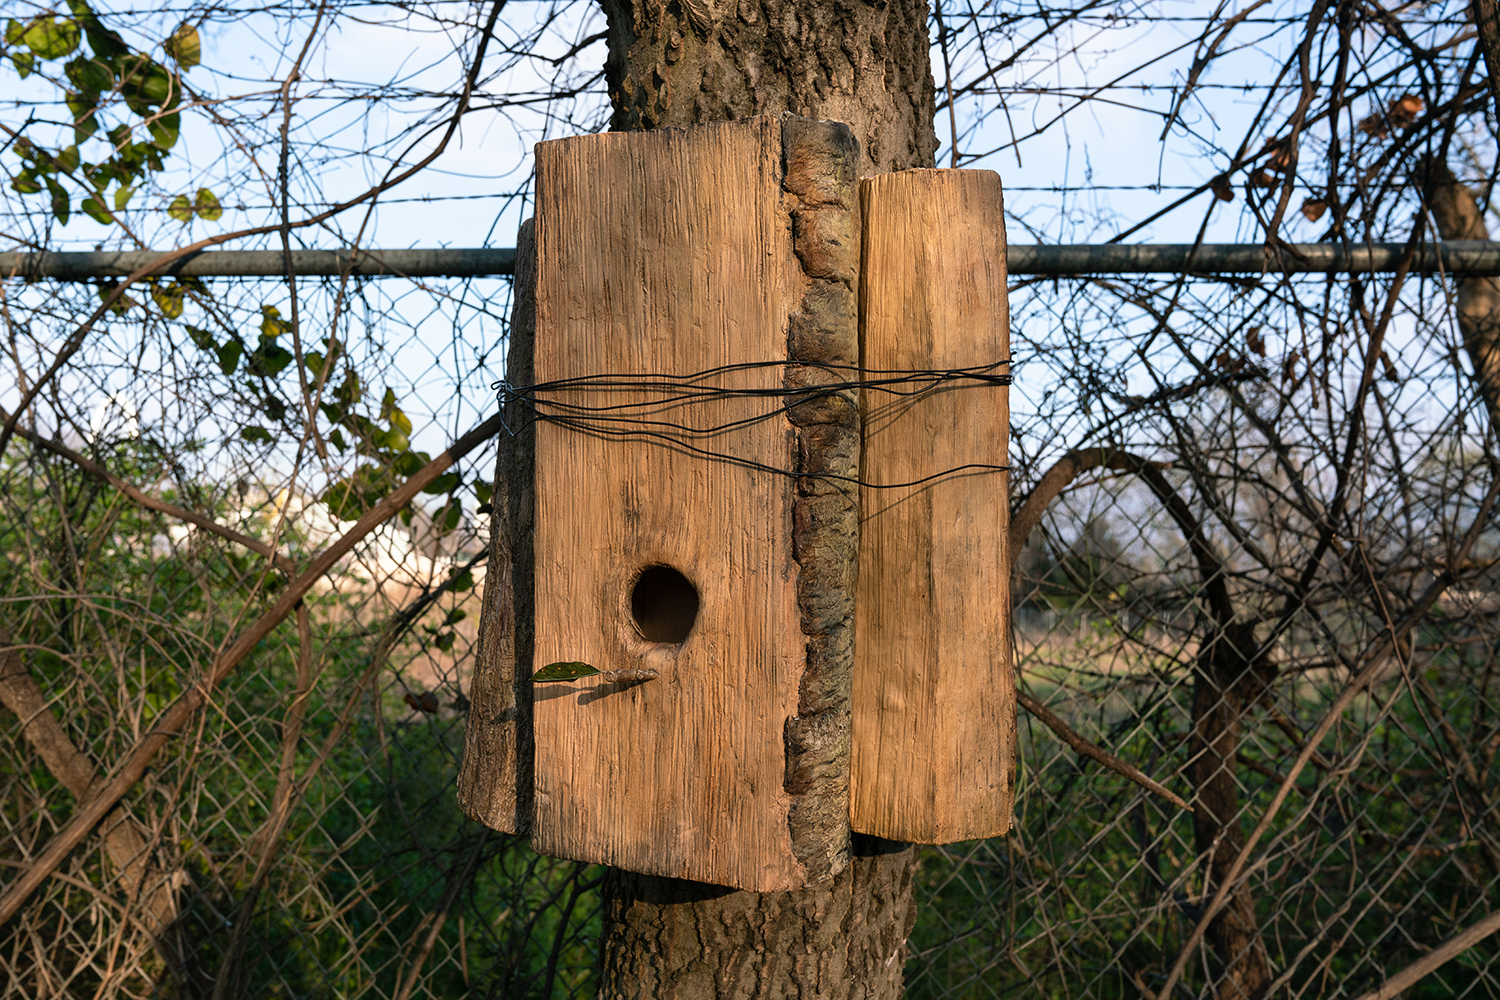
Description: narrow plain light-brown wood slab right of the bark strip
xmin=851 ymin=169 xmax=1016 ymax=844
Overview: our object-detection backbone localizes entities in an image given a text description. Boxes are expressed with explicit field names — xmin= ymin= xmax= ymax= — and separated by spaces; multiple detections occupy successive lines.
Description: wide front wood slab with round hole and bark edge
xmin=516 ymin=117 xmax=858 ymax=891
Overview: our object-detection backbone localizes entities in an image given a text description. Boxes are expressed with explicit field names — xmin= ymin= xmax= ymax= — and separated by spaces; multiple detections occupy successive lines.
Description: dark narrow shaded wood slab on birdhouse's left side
xmin=459 ymin=219 xmax=537 ymax=834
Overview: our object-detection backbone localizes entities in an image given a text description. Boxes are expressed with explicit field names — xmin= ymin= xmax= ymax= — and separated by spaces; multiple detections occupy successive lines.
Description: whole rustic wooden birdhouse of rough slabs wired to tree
xmin=459 ymin=115 xmax=1014 ymax=891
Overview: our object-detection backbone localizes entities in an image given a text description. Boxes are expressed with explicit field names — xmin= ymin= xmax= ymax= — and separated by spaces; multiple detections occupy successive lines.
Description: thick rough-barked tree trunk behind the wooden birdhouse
xmin=600 ymin=0 xmax=938 ymax=1000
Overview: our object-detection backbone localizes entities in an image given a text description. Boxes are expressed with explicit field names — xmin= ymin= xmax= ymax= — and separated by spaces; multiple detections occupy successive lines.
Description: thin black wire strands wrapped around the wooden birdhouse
xmin=491 ymin=358 xmax=1013 ymax=490
